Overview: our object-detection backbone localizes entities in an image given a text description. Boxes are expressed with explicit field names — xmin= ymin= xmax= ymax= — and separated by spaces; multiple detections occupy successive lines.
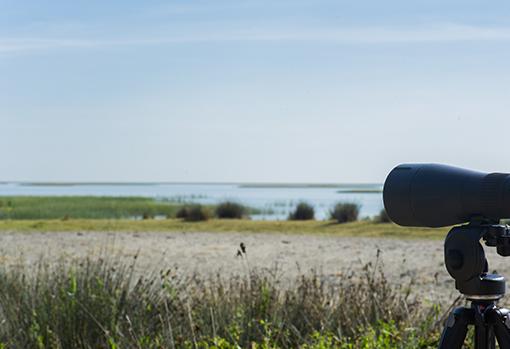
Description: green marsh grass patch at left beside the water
xmin=0 ymin=196 xmax=185 ymax=219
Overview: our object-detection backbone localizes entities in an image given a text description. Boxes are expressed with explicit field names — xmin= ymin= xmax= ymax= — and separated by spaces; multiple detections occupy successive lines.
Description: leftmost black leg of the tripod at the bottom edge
xmin=439 ymin=308 xmax=474 ymax=349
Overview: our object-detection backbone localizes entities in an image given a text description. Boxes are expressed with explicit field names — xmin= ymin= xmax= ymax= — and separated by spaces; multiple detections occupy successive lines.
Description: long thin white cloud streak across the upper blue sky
xmin=0 ymin=25 xmax=510 ymax=54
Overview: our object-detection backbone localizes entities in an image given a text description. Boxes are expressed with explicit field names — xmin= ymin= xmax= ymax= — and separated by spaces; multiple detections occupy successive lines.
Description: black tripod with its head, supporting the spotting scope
xmin=439 ymin=222 xmax=510 ymax=349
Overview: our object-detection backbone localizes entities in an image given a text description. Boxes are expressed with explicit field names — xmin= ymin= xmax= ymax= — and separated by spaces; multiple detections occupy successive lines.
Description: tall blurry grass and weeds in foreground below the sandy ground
xmin=0 ymin=255 xmax=454 ymax=349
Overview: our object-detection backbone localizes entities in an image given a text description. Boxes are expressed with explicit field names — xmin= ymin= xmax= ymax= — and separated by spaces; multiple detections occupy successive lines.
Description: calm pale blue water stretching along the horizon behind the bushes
xmin=0 ymin=183 xmax=383 ymax=220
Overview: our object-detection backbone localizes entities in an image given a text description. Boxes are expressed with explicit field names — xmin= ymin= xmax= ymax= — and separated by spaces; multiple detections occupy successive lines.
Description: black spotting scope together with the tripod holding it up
xmin=383 ymin=164 xmax=510 ymax=349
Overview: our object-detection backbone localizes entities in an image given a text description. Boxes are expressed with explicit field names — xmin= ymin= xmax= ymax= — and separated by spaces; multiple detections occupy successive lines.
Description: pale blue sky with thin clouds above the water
xmin=0 ymin=0 xmax=510 ymax=183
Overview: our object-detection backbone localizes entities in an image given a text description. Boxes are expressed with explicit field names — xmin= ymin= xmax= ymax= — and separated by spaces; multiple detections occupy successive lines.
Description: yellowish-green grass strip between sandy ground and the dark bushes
xmin=0 ymin=219 xmax=448 ymax=239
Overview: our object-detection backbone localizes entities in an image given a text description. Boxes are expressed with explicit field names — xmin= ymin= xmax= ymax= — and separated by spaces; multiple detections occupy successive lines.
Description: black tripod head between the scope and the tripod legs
xmin=444 ymin=218 xmax=510 ymax=300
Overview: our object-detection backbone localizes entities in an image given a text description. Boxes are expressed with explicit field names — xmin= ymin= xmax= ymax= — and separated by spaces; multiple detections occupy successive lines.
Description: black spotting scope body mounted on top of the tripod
xmin=383 ymin=164 xmax=510 ymax=227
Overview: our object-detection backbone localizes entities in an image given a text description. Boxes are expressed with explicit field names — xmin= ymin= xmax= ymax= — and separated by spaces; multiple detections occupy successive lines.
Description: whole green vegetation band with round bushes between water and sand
xmin=0 ymin=196 xmax=446 ymax=238
